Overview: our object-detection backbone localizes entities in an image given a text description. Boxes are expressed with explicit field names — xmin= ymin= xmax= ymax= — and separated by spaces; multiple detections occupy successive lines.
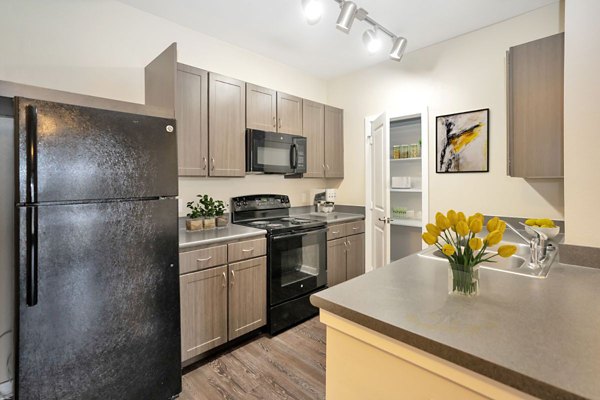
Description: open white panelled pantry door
xmin=369 ymin=113 xmax=390 ymax=268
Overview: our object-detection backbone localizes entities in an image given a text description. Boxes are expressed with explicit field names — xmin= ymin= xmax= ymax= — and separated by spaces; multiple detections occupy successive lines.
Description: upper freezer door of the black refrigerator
xmin=15 ymin=98 xmax=177 ymax=204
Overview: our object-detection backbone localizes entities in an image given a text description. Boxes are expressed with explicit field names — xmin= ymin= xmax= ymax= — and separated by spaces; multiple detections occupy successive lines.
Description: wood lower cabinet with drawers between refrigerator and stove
xmin=179 ymin=237 xmax=267 ymax=363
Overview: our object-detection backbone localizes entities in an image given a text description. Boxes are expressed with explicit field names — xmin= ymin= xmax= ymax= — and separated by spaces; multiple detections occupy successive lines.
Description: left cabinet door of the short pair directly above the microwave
xmin=246 ymin=83 xmax=277 ymax=132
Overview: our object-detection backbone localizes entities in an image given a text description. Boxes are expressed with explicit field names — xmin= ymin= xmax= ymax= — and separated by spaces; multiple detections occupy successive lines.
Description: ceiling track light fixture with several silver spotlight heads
xmin=302 ymin=0 xmax=408 ymax=61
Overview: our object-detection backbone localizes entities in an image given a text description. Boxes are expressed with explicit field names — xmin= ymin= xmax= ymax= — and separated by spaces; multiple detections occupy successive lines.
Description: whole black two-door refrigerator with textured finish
xmin=14 ymin=98 xmax=181 ymax=400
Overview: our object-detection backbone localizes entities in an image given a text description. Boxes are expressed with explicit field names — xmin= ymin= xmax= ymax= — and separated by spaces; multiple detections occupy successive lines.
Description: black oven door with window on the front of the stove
xmin=269 ymin=228 xmax=327 ymax=306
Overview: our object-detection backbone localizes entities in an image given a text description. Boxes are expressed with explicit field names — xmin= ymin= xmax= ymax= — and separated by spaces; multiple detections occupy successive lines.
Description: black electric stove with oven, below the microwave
xmin=231 ymin=194 xmax=327 ymax=334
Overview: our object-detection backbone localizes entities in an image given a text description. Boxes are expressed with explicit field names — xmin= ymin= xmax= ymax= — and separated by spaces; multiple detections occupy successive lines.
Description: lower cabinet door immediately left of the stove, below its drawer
xmin=229 ymin=257 xmax=267 ymax=340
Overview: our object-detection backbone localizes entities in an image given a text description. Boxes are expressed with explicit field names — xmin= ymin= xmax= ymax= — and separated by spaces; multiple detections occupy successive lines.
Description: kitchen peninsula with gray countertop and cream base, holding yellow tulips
xmin=311 ymin=255 xmax=600 ymax=400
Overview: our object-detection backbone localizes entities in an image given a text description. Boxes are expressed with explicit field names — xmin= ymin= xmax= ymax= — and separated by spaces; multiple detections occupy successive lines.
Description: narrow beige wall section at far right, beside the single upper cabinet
xmin=565 ymin=0 xmax=600 ymax=247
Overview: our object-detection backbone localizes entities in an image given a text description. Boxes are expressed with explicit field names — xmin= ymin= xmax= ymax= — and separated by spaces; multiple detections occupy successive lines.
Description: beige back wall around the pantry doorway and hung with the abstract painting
xmin=329 ymin=3 xmax=564 ymax=219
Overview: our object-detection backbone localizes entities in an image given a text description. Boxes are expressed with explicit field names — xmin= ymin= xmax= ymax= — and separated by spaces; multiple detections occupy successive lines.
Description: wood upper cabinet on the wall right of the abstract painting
xmin=507 ymin=33 xmax=564 ymax=178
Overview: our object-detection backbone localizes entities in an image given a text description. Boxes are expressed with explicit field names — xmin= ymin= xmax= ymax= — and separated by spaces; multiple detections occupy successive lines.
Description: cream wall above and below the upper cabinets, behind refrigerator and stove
xmin=0 ymin=0 xmax=327 ymax=213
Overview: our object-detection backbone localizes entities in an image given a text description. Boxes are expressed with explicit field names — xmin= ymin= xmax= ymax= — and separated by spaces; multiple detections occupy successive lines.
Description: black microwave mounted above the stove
xmin=246 ymin=129 xmax=306 ymax=174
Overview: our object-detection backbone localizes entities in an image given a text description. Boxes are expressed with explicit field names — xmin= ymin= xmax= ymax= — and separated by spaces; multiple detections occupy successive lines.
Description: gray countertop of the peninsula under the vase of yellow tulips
xmin=311 ymin=255 xmax=600 ymax=399
